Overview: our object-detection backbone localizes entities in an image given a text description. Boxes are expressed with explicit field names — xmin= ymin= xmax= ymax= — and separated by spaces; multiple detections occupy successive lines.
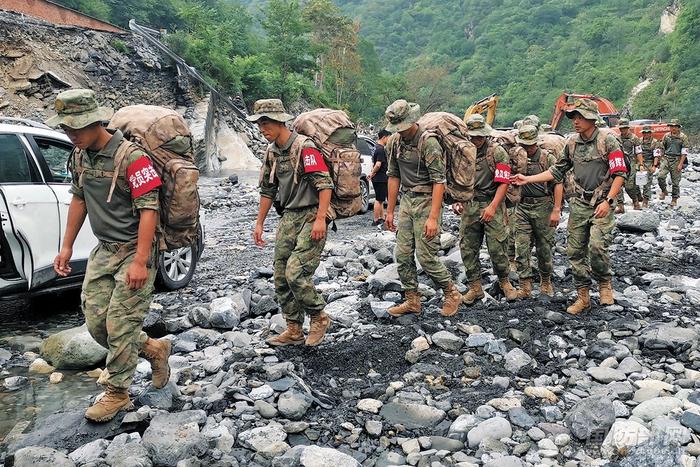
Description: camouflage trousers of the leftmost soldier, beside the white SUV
xmin=81 ymin=241 xmax=156 ymax=389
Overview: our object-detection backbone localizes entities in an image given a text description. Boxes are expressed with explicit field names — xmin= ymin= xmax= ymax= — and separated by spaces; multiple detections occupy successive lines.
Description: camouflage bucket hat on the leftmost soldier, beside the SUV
xmin=46 ymin=89 xmax=114 ymax=130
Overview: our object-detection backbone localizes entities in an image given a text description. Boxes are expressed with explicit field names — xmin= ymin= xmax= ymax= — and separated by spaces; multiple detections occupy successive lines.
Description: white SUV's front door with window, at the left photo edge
xmin=0 ymin=133 xmax=60 ymax=289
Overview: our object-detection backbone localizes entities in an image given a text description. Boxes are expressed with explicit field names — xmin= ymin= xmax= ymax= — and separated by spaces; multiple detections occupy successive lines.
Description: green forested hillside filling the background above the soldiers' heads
xmin=50 ymin=0 xmax=700 ymax=133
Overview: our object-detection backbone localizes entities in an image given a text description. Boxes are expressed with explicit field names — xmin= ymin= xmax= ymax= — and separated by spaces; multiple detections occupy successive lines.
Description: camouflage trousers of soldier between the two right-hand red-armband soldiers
xmin=512 ymin=196 xmax=554 ymax=280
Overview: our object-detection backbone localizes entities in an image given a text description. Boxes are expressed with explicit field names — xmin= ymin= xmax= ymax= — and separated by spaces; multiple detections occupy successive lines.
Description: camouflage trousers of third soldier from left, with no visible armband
xmin=396 ymin=192 xmax=452 ymax=292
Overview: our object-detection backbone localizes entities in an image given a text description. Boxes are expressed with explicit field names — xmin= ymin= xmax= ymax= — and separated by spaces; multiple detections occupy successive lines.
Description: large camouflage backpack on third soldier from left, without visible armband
xmin=410 ymin=112 xmax=476 ymax=202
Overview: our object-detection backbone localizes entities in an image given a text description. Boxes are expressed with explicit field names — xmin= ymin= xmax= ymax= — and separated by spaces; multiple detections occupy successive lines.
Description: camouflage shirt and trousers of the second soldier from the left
xmin=260 ymin=133 xmax=333 ymax=324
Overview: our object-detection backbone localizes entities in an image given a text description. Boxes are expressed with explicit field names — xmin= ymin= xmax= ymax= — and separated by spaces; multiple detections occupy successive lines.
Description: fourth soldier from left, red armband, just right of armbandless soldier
xmin=452 ymin=114 xmax=518 ymax=305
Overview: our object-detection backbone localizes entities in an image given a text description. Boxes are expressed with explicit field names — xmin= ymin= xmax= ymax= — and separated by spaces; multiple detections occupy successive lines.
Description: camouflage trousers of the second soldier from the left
xmin=274 ymin=206 xmax=326 ymax=324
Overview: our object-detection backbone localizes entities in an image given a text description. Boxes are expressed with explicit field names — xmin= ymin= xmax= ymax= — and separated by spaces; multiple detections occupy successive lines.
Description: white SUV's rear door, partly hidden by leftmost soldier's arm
xmin=30 ymin=136 xmax=97 ymax=266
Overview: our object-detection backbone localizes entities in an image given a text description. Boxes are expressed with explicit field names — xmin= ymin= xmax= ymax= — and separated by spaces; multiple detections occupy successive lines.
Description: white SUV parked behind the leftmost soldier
xmin=0 ymin=117 xmax=203 ymax=296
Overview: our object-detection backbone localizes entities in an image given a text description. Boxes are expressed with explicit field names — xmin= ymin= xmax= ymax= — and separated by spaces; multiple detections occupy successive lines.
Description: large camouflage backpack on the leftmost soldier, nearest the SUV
xmin=109 ymin=105 xmax=200 ymax=250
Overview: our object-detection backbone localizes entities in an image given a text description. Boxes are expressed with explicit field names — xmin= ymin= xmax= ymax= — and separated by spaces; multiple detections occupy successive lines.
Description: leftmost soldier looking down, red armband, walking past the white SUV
xmin=47 ymin=89 xmax=170 ymax=422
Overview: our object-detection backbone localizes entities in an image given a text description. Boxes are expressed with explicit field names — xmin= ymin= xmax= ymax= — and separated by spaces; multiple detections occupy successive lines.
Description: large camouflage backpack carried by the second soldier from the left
xmin=292 ymin=109 xmax=362 ymax=219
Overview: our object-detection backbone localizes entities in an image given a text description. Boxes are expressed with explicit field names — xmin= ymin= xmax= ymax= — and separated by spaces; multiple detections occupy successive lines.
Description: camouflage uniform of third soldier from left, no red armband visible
xmin=386 ymin=127 xmax=452 ymax=291
